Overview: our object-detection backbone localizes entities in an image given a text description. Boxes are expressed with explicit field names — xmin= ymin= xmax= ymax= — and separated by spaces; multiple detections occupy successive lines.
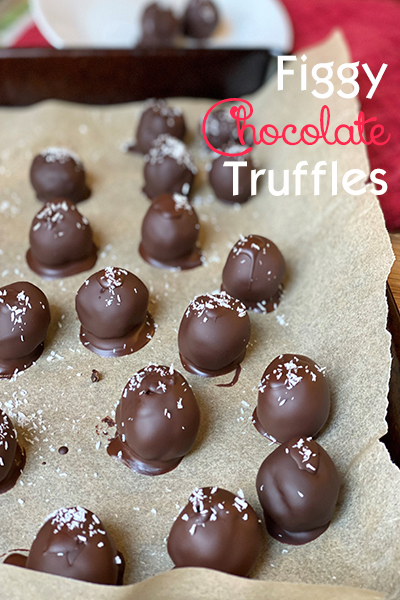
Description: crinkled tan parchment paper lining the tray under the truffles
xmin=0 ymin=34 xmax=400 ymax=600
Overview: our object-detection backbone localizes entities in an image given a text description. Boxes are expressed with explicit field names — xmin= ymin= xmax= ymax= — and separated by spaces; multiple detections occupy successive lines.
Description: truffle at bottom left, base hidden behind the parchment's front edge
xmin=26 ymin=506 xmax=124 ymax=585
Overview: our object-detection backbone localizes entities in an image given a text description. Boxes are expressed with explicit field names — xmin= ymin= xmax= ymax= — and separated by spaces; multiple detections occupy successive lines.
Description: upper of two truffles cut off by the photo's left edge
xmin=0 ymin=281 xmax=50 ymax=378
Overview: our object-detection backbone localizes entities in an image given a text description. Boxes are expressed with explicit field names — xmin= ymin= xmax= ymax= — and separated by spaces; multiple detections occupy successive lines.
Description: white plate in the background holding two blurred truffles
xmin=30 ymin=0 xmax=293 ymax=52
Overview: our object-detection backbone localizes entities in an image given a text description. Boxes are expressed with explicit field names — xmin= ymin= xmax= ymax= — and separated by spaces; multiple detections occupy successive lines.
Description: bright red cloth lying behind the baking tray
xmin=11 ymin=0 xmax=400 ymax=230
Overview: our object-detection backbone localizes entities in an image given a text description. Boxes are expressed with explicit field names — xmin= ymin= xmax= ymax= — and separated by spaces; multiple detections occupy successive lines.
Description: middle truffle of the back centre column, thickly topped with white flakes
xmin=143 ymin=133 xmax=197 ymax=200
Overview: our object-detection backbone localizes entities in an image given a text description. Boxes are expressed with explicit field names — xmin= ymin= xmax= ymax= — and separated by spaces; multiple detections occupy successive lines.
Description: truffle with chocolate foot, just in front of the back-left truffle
xmin=26 ymin=198 xmax=97 ymax=279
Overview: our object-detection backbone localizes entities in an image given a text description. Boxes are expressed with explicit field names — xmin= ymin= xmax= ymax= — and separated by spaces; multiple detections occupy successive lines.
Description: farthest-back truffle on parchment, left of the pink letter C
xmin=130 ymin=100 xmax=186 ymax=154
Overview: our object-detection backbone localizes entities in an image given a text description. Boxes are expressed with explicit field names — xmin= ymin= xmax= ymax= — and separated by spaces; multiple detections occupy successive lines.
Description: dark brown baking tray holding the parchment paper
xmin=0 ymin=48 xmax=400 ymax=467
